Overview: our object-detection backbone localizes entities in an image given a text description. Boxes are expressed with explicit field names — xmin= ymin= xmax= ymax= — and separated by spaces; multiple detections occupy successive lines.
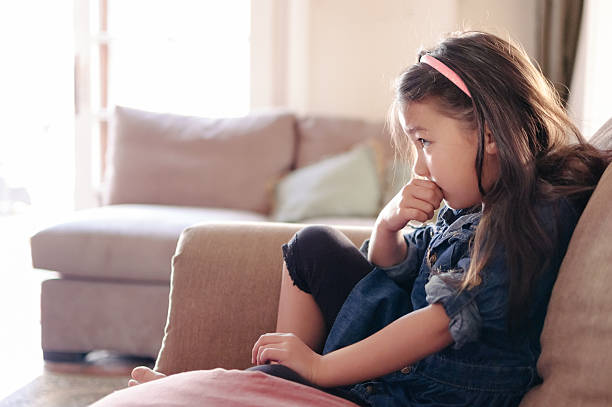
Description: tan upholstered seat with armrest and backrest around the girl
xmin=156 ymin=121 xmax=612 ymax=407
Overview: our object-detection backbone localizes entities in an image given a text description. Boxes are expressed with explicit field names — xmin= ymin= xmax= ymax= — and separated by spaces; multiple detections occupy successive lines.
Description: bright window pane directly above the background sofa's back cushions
xmin=108 ymin=0 xmax=250 ymax=117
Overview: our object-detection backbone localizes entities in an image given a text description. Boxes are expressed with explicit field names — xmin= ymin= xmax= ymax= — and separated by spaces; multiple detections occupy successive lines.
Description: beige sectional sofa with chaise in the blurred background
xmin=31 ymin=107 xmax=397 ymax=360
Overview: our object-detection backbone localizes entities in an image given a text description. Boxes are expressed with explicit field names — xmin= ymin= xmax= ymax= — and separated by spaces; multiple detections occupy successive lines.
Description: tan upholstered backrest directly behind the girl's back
xmin=521 ymin=161 xmax=612 ymax=407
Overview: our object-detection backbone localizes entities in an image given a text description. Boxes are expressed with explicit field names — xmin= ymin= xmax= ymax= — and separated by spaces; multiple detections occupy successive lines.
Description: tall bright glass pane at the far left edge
xmin=0 ymin=0 xmax=74 ymax=215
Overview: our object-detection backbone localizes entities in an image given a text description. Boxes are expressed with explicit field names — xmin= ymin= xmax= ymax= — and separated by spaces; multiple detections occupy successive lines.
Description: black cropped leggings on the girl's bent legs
xmin=249 ymin=225 xmax=373 ymax=406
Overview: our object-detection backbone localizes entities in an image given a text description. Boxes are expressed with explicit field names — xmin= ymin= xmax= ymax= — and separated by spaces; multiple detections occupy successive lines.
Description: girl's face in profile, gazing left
xmin=399 ymin=99 xmax=498 ymax=209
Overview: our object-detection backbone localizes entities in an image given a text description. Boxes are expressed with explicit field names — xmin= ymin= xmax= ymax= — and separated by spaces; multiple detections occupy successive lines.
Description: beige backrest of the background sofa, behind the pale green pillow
xmin=102 ymin=106 xmax=404 ymax=216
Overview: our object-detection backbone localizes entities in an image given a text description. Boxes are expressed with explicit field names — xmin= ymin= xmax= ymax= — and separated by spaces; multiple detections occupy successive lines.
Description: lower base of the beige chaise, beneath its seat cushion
xmin=41 ymin=278 xmax=170 ymax=358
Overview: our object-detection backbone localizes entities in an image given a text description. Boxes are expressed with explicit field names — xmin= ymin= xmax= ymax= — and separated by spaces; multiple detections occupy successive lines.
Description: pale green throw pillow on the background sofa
xmin=272 ymin=143 xmax=381 ymax=222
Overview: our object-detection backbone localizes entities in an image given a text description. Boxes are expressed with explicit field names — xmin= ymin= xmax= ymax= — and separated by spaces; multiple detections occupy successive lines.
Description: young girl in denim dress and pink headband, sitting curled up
xmin=133 ymin=32 xmax=611 ymax=406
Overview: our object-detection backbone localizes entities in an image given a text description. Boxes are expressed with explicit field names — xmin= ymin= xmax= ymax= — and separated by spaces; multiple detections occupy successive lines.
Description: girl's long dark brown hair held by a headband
xmin=389 ymin=31 xmax=611 ymax=331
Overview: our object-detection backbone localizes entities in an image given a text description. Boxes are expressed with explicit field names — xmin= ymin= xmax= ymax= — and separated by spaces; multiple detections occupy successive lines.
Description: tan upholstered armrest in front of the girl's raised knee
xmin=155 ymin=222 xmax=371 ymax=374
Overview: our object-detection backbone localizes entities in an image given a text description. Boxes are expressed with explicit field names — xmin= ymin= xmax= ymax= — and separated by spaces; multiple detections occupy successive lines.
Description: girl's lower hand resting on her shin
xmin=251 ymin=333 xmax=322 ymax=384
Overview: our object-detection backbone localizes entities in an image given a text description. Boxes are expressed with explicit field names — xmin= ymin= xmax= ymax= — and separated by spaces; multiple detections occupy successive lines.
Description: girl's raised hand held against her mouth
xmin=376 ymin=178 xmax=444 ymax=233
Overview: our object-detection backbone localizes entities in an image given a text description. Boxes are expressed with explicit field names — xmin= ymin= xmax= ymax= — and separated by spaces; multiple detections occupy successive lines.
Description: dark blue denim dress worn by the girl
xmin=323 ymin=199 xmax=579 ymax=407
